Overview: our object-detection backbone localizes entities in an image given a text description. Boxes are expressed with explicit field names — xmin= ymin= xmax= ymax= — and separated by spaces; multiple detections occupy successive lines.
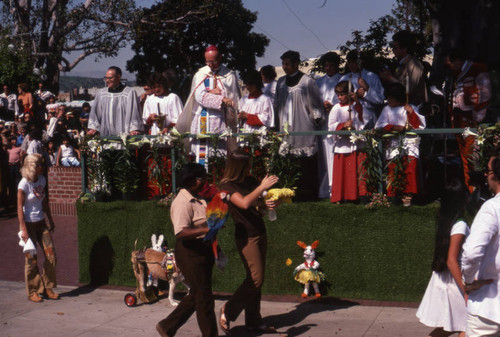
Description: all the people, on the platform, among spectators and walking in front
xmin=0 ymin=31 xmax=500 ymax=336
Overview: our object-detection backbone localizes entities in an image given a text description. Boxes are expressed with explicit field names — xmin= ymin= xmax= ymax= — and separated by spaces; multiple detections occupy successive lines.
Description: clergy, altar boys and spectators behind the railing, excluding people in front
xmin=0 ymin=31 xmax=491 ymax=205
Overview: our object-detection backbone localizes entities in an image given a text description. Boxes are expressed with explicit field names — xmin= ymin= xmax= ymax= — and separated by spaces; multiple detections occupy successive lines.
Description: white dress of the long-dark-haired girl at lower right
xmin=417 ymin=221 xmax=470 ymax=331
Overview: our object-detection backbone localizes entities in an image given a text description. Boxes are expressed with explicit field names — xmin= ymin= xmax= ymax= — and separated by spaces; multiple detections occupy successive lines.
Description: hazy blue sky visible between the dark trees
xmin=67 ymin=0 xmax=395 ymax=79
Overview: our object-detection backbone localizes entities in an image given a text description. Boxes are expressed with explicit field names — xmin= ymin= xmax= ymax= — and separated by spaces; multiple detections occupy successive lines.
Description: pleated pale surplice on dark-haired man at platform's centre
xmin=275 ymin=74 xmax=325 ymax=157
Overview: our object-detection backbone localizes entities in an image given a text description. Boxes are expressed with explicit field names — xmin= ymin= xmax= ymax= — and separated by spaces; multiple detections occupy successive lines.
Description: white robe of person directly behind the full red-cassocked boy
xmin=316 ymin=73 xmax=342 ymax=198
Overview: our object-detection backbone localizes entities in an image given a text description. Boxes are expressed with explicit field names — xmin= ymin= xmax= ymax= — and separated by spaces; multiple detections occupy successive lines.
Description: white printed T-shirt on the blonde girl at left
xmin=17 ymin=175 xmax=45 ymax=222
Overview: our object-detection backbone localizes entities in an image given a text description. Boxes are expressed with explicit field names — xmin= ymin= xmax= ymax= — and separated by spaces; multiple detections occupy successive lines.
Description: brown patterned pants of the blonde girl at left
xmin=24 ymin=220 xmax=57 ymax=297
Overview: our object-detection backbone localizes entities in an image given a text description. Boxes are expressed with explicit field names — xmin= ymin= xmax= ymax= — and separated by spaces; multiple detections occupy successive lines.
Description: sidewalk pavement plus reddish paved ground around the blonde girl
xmin=0 ymin=206 xmax=432 ymax=337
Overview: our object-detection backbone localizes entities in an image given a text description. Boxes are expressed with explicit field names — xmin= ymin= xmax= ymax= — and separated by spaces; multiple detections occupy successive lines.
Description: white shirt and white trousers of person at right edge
xmin=462 ymin=193 xmax=500 ymax=324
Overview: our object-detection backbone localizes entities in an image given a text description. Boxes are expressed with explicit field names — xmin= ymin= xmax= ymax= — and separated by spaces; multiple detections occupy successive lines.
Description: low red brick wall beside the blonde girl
xmin=48 ymin=167 xmax=82 ymax=215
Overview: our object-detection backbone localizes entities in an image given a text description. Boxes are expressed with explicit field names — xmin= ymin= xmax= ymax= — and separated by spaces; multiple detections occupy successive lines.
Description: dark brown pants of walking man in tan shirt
xmin=159 ymin=239 xmax=218 ymax=337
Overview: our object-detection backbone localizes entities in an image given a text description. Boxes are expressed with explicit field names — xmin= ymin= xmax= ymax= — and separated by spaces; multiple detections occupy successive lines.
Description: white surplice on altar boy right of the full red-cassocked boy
xmin=375 ymin=105 xmax=425 ymax=160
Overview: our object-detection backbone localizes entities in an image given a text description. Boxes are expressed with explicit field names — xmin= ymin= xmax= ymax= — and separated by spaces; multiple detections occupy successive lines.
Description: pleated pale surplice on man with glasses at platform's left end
xmin=88 ymin=87 xmax=143 ymax=137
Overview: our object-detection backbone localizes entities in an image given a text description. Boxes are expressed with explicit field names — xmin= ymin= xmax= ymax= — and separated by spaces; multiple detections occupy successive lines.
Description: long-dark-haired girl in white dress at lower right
xmin=417 ymin=180 xmax=469 ymax=337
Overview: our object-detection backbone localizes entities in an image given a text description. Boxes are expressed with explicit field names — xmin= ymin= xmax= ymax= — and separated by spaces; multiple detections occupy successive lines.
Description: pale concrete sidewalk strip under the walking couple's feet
xmin=0 ymin=281 xmax=431 ymax=337
